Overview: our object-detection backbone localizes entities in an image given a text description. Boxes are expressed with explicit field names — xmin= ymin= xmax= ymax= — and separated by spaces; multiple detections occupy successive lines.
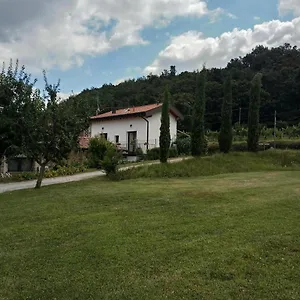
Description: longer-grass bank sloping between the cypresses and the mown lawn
xmin=112 ymin=150 xmax=300 ymax=180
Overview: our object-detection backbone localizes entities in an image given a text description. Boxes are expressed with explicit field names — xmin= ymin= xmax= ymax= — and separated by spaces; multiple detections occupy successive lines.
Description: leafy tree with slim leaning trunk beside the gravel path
xmin=20 ymin=73 xmax=87 ymax=188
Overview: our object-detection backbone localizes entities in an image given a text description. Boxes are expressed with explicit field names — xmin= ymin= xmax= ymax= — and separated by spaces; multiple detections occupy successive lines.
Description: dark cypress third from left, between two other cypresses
xmin=219 ymin=75 xmax=232 ymax=153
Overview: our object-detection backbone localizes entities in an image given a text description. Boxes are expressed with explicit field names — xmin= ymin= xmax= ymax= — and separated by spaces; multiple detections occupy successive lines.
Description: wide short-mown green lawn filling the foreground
xmin=0 ymin=171 xmax=300 ymax=300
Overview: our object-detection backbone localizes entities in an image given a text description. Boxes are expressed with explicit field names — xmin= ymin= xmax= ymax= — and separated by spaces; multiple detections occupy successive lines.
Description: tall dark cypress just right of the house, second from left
xmin=191 ymin=68 xmax=207 ymax=156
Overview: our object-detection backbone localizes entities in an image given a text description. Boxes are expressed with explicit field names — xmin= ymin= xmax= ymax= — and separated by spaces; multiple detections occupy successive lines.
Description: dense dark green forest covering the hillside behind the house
xmin=68 ymin=44 xmax=300 ymax=131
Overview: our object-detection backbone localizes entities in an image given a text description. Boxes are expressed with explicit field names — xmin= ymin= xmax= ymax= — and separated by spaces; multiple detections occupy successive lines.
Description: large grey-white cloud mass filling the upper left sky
xmin=0 ymin=0 xmax=227 ymax=71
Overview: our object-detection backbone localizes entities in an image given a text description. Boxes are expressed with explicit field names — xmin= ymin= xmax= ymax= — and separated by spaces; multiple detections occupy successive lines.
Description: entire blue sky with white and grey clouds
xmin=0 ymin=0 xmax=300 ymax=98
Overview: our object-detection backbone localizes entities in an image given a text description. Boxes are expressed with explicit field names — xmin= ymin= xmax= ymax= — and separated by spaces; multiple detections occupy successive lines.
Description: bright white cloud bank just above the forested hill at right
xmin=144 ymin=18 xmax=300 ymax=74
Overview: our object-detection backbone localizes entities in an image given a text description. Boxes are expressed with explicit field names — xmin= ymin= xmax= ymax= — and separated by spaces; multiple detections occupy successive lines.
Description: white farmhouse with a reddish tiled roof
xmin=90 ymin=103 xmax=182 ymax=155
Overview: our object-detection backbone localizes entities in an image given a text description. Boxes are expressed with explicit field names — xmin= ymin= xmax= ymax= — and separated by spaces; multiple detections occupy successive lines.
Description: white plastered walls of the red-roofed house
xmin=91 ymin=111 xmax=177 ymax=151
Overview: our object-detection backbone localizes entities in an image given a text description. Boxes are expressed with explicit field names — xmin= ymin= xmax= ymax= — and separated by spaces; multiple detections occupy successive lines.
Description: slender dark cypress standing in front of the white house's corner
xmin=159 ymin=88 xmax=171 ymax=163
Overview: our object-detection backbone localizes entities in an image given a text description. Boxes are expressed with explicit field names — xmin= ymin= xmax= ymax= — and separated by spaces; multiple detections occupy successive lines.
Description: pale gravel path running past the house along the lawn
xmin=0 ymin=157 xmax=189 ymax=193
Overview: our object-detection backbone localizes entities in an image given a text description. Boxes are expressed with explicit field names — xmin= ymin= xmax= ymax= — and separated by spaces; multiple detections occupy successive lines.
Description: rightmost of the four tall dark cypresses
xmin=248 ymin=73 xmax=262 ymax=152
